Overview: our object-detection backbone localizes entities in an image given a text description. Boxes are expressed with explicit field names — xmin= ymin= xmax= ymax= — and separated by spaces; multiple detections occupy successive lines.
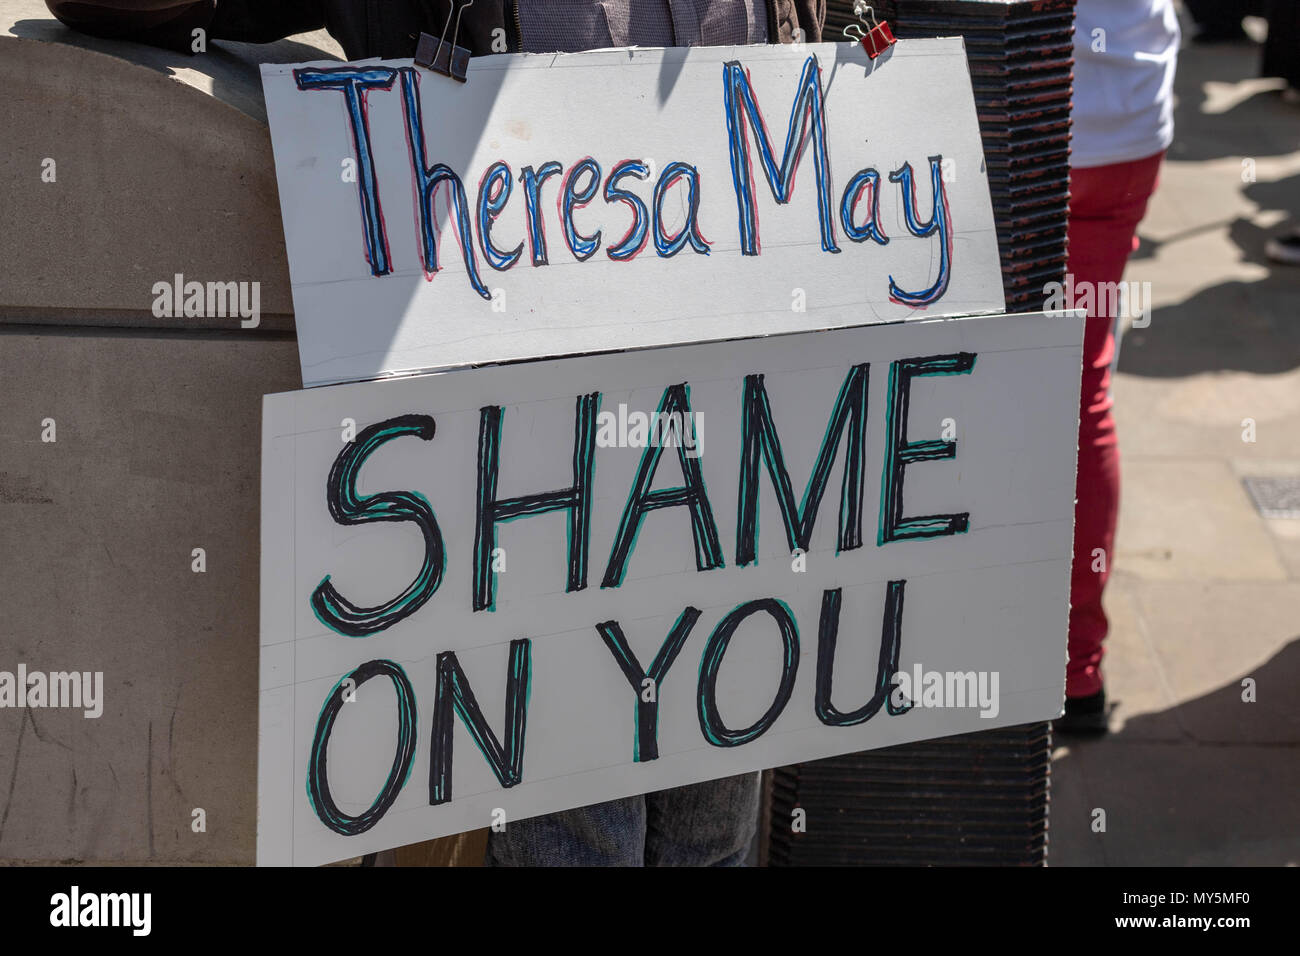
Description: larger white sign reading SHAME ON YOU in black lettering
xmin=257 ymin=313 xmax=1082 ymax=864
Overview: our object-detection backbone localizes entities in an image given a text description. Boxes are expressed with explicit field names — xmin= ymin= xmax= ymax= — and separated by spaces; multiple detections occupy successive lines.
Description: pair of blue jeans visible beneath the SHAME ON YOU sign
xmin=486 ymin=774 xmax=758 ymax=866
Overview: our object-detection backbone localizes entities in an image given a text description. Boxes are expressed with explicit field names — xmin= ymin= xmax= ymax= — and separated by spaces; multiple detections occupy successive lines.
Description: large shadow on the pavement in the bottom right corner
xmin=1048 ymin=642 xmax=1300 ymax=866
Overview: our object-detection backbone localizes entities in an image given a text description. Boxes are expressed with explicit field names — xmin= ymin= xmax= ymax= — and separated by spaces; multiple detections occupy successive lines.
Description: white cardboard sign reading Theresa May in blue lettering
xmin=261 ymin=38 xmax=1004 ymax=385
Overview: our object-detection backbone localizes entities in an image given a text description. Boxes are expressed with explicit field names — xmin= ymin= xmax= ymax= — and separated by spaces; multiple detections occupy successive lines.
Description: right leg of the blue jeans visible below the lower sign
xmin=645 ymin=774 xmax=758 ymax=866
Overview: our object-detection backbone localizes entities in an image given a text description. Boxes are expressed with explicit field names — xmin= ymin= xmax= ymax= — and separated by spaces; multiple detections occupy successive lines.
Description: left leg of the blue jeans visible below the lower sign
xmin=485 ymin=796 xmax=646 ymax=866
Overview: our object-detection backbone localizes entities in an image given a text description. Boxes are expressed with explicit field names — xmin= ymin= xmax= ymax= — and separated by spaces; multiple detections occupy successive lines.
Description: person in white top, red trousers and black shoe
xmin=1057 ymin=0 xmax=1180 ymax=734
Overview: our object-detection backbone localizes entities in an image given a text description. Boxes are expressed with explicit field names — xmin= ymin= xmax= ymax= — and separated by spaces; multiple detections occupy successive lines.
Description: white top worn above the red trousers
xmin=1070 ymin=0 xmax=1180 ymax=166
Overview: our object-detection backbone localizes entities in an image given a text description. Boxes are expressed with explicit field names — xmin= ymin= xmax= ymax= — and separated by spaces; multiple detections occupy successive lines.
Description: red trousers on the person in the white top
xmin=1065 ymin=153 xmax=1164 ymax=697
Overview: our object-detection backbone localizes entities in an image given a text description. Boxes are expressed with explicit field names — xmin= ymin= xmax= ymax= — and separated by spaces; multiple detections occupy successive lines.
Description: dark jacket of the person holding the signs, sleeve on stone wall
xmin=46 ymin=0 xmax=826 ymax=60
